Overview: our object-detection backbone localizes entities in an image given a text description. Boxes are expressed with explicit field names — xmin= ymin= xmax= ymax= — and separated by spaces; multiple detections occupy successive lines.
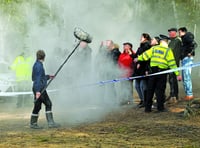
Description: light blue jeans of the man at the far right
xmin=181 ymin=57 xmax=193 ymax=96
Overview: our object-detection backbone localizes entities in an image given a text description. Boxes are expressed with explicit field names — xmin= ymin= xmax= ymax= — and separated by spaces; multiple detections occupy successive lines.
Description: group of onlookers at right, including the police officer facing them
xmin=98 ymin=27 xmax=197 ymax=112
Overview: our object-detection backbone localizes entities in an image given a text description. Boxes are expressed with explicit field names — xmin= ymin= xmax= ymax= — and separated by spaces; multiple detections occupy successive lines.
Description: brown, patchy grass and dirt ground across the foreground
xmin=0 ymin=98 xmax=200 ymax=148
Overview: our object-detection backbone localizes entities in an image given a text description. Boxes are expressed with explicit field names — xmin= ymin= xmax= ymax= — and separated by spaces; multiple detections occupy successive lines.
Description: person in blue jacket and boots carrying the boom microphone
xmin=30 ymin=50 xmax=60 ymax=129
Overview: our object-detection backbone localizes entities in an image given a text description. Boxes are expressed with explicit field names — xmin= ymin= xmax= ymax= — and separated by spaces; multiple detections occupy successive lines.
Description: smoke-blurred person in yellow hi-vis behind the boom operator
xmin=11 ymin=51 xmax=34 ymax=108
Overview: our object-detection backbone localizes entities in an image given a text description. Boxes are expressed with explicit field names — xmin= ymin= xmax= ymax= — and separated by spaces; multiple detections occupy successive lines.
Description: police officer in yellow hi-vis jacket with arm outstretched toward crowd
xmin=134 ymin=35 xmax=181 ymax=112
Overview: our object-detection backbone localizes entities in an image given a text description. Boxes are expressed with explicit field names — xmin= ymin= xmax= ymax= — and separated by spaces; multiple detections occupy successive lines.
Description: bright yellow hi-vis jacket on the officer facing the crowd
xmin=138 ymin=43 xmax=179 ymax=76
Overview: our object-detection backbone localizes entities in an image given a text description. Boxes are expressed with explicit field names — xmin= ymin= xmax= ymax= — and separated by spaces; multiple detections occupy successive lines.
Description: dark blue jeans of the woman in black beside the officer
xmin=135 ymin=79 xmax=147 ymax=101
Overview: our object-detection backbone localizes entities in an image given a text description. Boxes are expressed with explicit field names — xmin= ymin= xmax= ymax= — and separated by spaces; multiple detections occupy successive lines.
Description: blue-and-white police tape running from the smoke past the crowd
xmin=82 ymin=62 xmax=200 ymax=86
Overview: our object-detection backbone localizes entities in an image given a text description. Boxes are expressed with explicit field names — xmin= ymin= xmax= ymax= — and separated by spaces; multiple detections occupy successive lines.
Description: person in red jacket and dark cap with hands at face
xmin=118 ymin=42 xmax=135 ymax=105
